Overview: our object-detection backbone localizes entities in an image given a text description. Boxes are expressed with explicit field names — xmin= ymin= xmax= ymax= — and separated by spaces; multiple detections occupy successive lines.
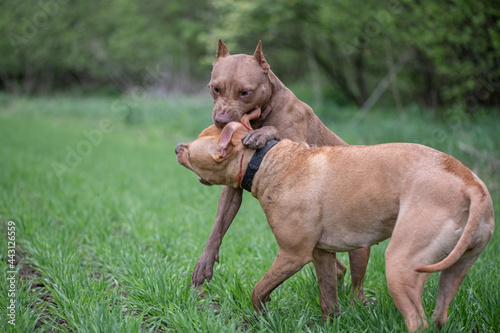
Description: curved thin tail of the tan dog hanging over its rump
xmin=415 ymin=182 xmax=488 ymax=273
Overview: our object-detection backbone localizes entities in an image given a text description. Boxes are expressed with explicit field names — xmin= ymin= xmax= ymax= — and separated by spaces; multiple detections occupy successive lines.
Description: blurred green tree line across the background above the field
xmin=0 ymin=0 xmax=500 ymax=112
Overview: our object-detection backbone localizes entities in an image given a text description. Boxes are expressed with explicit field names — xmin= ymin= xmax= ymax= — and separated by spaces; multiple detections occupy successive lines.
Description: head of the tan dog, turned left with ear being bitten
xmin=175 ymin=109 xmax=260 ymax=187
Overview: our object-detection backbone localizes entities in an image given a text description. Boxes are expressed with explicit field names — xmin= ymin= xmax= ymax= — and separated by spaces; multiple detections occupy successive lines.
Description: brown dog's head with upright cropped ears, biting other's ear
xmin=208 ymin=39 xmax=272 ymax=128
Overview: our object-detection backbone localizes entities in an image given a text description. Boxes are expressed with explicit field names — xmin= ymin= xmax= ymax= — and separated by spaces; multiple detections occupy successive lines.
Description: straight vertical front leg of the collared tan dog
xmin=313 ymin=248 xmax=340 ymax=322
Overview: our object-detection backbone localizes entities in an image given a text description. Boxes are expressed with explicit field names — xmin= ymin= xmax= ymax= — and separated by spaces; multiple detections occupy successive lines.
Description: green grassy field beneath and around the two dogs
xmin=0 ymin=94 xmax=500 ymax=333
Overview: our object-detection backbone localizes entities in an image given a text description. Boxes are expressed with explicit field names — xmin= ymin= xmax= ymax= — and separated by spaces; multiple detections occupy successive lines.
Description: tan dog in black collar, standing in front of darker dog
xmin=176 ymin=113 xmax=494 ymax=331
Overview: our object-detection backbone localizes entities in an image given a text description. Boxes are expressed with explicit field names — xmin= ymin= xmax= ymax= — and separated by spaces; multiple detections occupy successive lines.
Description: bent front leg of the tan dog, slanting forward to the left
xmin=252 ymin=250 xmax=312 ymax=313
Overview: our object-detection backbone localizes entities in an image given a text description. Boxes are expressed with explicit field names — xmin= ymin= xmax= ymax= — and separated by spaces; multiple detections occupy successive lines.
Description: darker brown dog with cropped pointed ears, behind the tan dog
xmin=192 ymin=40 xmax=370 ymax=300
